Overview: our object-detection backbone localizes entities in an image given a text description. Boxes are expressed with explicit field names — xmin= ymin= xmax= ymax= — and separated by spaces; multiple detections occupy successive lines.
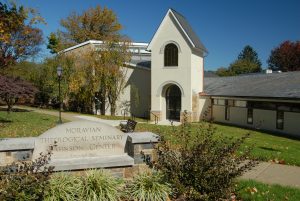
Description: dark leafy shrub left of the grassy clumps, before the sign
xmin=0 ymin=147 xmax=53 ymax=201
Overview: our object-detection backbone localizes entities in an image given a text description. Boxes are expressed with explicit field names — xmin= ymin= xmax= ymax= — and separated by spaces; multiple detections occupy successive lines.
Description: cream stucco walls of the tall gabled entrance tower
xmin=151 ymin=12 xmax=203 ymax=119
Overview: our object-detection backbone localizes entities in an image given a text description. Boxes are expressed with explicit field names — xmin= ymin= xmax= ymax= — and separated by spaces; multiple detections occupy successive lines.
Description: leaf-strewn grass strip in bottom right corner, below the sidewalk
xmin=237 ymin=180 xmax=300 ymax=201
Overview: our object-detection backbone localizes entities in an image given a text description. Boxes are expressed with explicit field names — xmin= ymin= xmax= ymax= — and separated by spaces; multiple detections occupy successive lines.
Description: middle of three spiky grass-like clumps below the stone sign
xmin=81 ymin=170 xmax=123 ymax=201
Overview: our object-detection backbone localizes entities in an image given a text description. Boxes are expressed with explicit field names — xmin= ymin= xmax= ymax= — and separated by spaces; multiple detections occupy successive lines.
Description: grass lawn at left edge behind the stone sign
xmin=0 ymin=109 xmax=57 ymax=138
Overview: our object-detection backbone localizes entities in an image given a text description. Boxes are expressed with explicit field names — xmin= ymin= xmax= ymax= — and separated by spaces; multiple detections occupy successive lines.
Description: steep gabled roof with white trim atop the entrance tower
xmin=147 ymin=9 xmax=208 ymax=53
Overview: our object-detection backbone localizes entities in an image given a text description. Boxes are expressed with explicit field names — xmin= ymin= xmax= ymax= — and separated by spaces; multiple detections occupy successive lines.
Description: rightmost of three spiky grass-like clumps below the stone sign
xmin=126 ymin=172 xmax=171 ymax=201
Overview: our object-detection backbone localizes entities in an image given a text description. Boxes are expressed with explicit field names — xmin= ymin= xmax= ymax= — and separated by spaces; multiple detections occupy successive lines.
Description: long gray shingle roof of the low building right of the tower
xmin=204 ymin=71 xmax=300 ymax=99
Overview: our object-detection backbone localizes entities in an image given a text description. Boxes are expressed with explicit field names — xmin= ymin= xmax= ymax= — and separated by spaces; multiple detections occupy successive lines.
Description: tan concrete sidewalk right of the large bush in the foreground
xmin=240 ymin=162 xmax=300 ymax=188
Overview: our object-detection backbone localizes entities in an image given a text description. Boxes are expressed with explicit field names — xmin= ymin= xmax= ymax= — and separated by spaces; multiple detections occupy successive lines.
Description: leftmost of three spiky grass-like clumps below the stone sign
xmin=45 ymin=173 xmax=82 ymax=201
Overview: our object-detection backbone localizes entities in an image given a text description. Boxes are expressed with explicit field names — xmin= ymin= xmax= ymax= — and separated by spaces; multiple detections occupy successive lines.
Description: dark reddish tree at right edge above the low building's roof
xmin=268 ymin=41 xmax=300 ymax=71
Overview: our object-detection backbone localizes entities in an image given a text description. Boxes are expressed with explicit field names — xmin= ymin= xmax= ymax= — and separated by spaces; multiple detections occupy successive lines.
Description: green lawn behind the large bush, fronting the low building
xmin=136 ymin=123 xmax=300 ymax=166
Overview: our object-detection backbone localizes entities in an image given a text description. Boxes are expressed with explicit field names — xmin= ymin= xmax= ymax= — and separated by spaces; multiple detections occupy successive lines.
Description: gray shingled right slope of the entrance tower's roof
xmin=171 ymin=9 xmax=208 ymax=53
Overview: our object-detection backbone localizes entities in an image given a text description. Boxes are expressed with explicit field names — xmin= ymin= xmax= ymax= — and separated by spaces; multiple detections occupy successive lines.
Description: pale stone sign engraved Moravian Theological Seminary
xmin=32 ymin=121 xmax=133 ymax=170
